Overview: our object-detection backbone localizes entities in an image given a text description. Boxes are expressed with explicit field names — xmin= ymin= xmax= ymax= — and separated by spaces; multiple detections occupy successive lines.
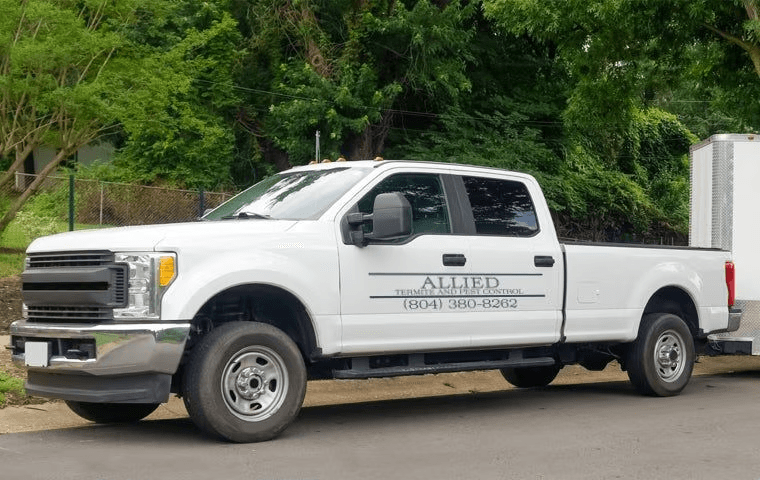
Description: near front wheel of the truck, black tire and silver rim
xmin=184 ymin=322 xmax=306 ymax=443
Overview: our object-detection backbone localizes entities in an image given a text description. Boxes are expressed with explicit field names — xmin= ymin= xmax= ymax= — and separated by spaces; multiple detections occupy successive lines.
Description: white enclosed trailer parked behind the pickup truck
xmin=689 ymin=134 xmax=760 ymax=355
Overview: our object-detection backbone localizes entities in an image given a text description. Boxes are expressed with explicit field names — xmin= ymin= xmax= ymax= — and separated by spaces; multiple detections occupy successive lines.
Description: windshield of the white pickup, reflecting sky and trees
xmin=203 ymin=167 xmax=371 ymax=220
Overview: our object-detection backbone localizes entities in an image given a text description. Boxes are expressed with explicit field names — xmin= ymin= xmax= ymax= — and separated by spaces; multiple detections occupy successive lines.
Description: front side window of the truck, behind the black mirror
xmin=358 ymin=173 xmax=451 ymax=235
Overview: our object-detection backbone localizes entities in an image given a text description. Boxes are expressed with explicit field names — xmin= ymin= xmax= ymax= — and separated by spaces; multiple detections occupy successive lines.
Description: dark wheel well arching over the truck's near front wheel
xmin=190 ymin=285 xmax=317 ymax=361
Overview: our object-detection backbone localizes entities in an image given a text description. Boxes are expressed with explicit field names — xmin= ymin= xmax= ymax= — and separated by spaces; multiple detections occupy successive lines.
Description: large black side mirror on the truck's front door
xmin=346 ymin=192 xmax=412 ymax=247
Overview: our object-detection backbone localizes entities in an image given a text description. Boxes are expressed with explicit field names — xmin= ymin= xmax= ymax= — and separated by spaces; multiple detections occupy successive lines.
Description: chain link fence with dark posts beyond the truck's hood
xmin=0 ymin=174 xmax=234 ymax=229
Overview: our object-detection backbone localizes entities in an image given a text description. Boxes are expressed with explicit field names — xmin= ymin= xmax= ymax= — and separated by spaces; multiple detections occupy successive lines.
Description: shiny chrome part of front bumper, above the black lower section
xmin=10 ymin=320 xmax=190 ymax=376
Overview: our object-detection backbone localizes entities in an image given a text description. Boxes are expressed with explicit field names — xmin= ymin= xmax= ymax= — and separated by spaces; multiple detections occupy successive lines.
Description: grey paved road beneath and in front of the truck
xmin=0 ymin=371 xmax=760 ymax=480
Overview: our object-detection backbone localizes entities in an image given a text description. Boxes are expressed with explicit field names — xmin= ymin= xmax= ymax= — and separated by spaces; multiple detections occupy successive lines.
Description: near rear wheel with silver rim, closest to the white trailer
xmin=625 ymin=313 xmax=696 ymax=397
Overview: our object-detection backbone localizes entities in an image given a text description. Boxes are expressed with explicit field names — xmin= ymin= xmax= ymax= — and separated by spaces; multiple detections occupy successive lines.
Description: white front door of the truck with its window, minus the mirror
xmin=339 ymin=172 xmax=473 ymax=354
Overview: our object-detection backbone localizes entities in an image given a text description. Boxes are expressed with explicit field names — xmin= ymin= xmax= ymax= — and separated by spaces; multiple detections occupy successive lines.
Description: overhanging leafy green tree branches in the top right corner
xmin=484 ymin=0 xmax=760 ymax=136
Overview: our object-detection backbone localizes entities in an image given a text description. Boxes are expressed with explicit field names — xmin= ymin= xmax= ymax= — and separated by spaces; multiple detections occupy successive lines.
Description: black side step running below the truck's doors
xmin=332 ymin=351 xmax=557 ymax=379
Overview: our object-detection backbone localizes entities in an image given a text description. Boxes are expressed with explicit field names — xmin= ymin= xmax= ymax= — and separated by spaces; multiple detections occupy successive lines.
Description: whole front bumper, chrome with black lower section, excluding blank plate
xmin=10 ymin=320 xmax=190 ymax=403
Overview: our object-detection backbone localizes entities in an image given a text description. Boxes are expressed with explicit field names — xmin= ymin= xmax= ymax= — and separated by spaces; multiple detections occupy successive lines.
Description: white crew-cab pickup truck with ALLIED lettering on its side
xmin=9 ymin=161 xmax=741 ymax=442
